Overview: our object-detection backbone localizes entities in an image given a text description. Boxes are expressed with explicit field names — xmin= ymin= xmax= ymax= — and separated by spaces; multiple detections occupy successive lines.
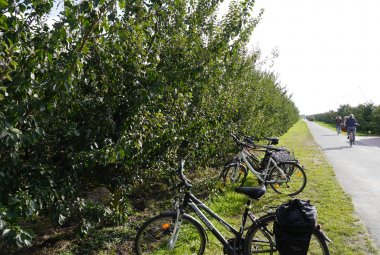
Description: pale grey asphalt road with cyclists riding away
xmin=307 ymin=121 xmax=380 ymax=248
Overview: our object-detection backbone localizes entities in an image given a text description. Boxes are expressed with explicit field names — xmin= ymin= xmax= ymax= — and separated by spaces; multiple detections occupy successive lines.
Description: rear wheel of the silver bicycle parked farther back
xmin=268 ymin=161 xmax=307 ymax=196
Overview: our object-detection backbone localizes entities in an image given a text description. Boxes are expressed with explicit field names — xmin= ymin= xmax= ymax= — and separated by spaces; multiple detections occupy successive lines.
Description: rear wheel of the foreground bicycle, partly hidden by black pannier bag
xmin=244 ymin=214 xmax=330 ymax=255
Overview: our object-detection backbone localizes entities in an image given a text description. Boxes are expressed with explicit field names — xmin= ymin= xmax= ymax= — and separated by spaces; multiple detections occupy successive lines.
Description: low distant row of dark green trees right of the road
xmin=307 ymin=103 xmax=380 ymax=134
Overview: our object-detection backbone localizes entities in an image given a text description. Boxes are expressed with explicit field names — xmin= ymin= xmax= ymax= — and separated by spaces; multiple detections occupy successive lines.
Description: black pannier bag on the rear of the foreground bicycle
xmin=273 ymin=199 xmax=317 ymax=255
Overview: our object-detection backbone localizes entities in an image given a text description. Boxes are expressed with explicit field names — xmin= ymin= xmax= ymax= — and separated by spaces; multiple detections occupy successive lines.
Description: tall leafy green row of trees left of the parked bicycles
xmin=0 ymin=0 xmax=299 ymax=248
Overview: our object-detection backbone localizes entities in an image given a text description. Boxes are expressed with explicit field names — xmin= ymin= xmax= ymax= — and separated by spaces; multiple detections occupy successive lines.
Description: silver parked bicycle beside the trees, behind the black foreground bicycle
xmin=220 ymin=134 xmax=307 ymax=196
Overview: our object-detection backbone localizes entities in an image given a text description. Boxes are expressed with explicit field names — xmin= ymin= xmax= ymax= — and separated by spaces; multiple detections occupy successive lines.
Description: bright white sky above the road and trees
xmin=243 ymin=0 xmax=380 ymax=115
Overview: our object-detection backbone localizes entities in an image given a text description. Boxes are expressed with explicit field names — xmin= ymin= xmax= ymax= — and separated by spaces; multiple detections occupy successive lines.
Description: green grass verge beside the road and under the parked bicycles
xmin=9 ymin=121 xmax=380 ymax=255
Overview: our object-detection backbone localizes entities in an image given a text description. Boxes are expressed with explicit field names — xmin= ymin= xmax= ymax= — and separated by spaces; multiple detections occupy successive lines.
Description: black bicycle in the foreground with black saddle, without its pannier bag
xmin=135 ymin=160 xmax=330 ymax=255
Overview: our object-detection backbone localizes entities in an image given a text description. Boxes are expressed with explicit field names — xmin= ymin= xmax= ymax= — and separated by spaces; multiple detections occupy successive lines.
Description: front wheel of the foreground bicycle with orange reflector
xmin=135 ymin=212 xmax=206 ymax=255
